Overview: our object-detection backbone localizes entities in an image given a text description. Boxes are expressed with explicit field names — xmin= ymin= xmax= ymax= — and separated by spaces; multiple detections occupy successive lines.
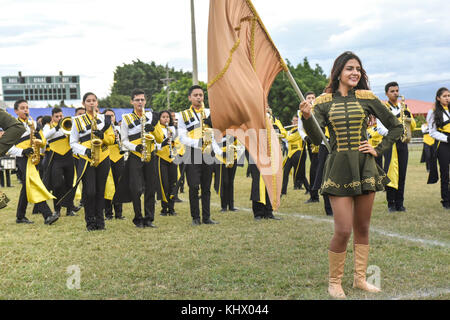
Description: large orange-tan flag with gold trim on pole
xmin=208 ymin=0 xmax=287 ymax=210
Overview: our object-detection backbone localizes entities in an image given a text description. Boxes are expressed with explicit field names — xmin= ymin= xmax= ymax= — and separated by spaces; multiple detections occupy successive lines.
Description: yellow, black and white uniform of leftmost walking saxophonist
xmin=8 ymin=118 xmax=57 ymax=223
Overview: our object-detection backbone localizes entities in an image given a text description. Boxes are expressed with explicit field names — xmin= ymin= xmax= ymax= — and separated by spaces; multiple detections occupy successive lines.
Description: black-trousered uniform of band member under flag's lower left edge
xmin=214 ymin=135 xmax=238 ymax=212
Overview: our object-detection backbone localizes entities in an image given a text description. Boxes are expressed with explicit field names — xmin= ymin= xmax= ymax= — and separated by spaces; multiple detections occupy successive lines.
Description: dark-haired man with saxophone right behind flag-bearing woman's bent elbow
xmin=377 ymin=82 xmax=416 ymax=212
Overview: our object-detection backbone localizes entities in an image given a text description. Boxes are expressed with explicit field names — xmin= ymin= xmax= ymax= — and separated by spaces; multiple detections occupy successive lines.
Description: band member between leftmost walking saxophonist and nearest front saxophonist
xmin=43 ymin=107 xmax=75 ymax=216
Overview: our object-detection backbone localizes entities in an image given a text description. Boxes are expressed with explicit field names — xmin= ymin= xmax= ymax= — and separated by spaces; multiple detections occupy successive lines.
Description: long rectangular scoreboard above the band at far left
xmin=2 ymin=72 xmax=80 ymax=101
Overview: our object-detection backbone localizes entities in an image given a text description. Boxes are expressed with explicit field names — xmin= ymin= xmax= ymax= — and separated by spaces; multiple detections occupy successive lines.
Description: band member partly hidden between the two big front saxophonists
xmin=103 ymin=109 xmax=125 ymax=220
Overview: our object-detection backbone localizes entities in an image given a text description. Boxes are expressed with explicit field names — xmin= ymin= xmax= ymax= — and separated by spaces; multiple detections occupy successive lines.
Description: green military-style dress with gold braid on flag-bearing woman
xmin=302 ymin=90 xmax=403 ymax=196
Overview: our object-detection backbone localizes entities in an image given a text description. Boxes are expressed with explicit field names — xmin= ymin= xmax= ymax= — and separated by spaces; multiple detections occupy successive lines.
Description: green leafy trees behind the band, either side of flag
xmin=94 ymin=58 xmax=328 ymax=125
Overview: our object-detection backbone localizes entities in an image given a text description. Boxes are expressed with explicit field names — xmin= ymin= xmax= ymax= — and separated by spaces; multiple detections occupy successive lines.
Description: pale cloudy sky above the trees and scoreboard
xmin=0 ymin=0 xmax=450 ymax=105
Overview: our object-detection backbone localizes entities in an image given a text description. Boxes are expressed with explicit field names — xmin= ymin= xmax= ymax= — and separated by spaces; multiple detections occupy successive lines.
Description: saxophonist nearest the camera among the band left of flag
xmin=70 ymin=92 xmax=114 ymax=231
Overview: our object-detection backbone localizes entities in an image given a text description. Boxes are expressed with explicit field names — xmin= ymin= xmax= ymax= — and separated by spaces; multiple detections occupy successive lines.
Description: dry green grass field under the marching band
xmin=0 ymin=148 xmax=450 ymax=300
